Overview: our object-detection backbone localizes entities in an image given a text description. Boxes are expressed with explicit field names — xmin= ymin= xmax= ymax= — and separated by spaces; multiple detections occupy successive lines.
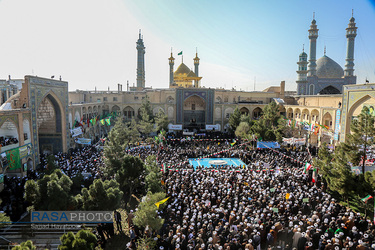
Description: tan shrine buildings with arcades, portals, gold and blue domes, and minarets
xmin=0 ymin=14 xmax=375 ymax=179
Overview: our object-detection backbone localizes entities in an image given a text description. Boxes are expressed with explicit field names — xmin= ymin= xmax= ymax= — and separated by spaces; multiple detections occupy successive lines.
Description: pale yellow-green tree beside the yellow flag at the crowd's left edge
xmin=133 ymin=193 xmax=166 ymax=232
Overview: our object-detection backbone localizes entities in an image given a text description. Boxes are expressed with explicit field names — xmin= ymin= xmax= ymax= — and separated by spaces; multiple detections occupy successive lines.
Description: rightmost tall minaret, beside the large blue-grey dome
xmin=345 ymin=13 xmax=357 ymax=76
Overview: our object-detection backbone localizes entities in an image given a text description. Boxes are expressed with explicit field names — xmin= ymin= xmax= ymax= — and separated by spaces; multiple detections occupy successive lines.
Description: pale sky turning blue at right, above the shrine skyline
xmin=0 ymin=0 xmax=375 ymax=91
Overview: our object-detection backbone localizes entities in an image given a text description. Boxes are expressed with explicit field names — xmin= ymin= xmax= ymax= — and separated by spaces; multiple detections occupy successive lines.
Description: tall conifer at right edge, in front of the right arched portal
xmin=342 ymin=106 xmax=375 ymax=174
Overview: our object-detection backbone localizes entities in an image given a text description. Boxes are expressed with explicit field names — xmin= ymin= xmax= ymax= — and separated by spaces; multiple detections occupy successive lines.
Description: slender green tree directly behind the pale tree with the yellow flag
xmin=145 ymin=155 xmax=162 ymax=193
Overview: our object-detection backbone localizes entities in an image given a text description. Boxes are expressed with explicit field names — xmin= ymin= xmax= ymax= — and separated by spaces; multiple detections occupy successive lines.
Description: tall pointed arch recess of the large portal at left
xmin=37 ymin=94 xmax=63 ymax=154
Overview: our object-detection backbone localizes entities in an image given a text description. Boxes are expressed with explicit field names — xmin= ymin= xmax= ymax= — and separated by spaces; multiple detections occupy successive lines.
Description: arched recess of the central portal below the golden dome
xmin=183 ymin=95 xmax=206 ymax=131
